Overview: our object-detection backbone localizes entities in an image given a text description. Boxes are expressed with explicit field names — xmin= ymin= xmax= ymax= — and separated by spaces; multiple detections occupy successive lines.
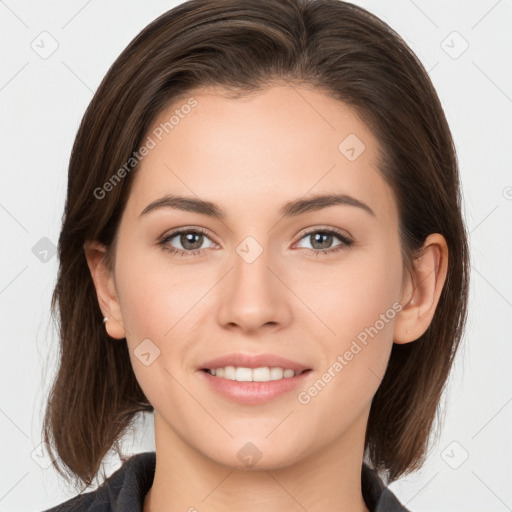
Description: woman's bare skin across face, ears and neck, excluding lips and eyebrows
xmin=85 ymin=86 xmax=447 ymax=512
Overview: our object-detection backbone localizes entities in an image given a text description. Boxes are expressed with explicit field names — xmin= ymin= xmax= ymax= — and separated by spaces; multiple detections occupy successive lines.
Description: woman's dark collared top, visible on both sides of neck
xmin=44 ymin=452 xmax=410 ymax=512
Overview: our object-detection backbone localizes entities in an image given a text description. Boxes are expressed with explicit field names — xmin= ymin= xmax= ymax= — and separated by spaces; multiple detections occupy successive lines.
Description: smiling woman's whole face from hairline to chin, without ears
xmin=106 ymin=86 xmax=410 ymax=468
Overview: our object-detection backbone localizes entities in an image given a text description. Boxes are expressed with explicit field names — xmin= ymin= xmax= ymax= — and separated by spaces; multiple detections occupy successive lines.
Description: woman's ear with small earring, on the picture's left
xmin=84 ymin=241 xmax=126 ymax=339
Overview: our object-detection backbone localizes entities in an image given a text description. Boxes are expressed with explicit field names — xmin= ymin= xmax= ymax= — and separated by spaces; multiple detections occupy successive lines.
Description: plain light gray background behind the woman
xmin=0 ymin=0 xmax=512 ymax=512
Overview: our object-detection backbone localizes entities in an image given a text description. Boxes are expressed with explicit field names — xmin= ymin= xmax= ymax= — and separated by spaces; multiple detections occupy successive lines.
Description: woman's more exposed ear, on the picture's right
xmin=393 ymin=233 xmax=448 ymax=344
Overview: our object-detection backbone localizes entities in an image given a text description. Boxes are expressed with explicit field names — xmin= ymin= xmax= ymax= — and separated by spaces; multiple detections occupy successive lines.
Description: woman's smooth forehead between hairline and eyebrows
xmin=125 ymin=86 xmax=394 ymax=223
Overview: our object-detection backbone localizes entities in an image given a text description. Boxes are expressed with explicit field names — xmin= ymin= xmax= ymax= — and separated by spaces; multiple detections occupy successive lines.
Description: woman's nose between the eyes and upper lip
xmin=218 ymin=242 xmax=293 ymax=333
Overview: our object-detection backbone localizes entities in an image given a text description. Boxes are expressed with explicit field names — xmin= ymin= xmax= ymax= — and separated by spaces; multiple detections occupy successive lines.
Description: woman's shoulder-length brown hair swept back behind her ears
xmin=43 ymin=0 xmax=469 ymax=486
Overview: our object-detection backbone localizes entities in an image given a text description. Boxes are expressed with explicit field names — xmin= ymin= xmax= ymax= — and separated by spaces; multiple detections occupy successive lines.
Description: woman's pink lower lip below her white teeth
xmin=199 ymin=370 xmax=311 ymax=405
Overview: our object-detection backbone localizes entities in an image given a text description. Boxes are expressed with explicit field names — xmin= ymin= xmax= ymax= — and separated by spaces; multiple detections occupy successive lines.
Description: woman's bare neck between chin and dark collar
xmin=144 ymin=411 xmax=368 ymax=512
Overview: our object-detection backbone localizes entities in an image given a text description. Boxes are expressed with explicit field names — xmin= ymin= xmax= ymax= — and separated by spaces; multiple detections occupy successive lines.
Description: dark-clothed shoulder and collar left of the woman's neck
xmin=43 ymin=452 xmax=156 ymax=512
